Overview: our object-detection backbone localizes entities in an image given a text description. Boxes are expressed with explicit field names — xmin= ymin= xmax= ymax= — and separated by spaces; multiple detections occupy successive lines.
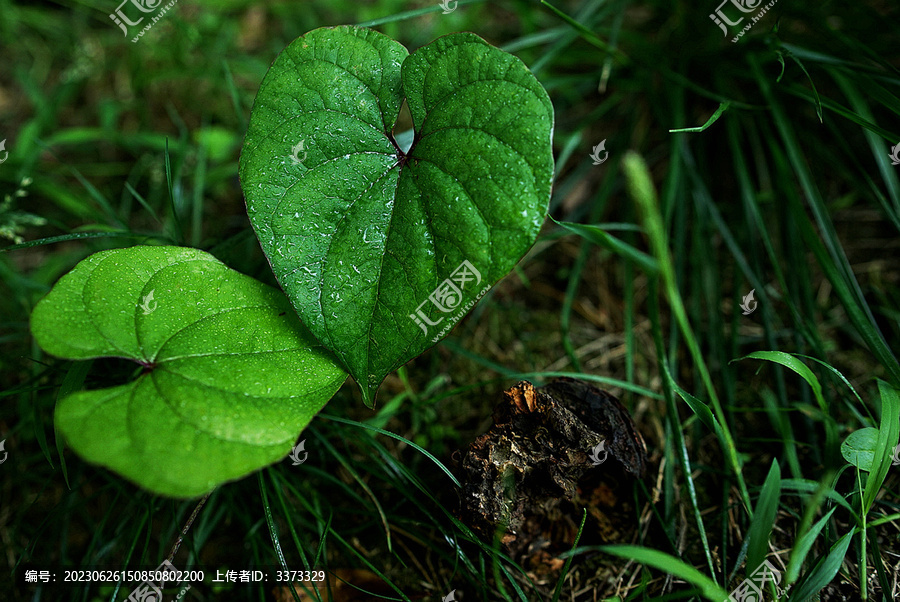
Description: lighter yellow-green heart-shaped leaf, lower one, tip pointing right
xmin=31 ymin=247 xmax=347 ymax=497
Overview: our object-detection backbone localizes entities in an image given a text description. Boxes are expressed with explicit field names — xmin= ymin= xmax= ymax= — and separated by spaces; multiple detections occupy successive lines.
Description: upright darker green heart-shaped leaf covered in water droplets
xmin=240 ymin=27 xmax=553 ymax=405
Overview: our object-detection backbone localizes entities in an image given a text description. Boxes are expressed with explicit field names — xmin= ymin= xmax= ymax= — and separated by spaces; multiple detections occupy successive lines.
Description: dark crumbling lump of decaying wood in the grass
xmin=460 ymin=378 xmax=647 ymax=577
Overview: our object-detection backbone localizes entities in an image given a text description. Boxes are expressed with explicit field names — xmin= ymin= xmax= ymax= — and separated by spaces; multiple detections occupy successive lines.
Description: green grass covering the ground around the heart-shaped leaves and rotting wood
xmin=0 ymin=0 xmax=900 ymax=602
